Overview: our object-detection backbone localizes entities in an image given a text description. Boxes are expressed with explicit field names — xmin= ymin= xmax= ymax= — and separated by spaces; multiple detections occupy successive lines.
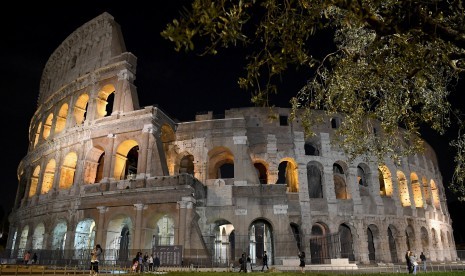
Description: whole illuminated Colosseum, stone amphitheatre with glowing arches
xmin=7 ymin=13 xmax=457 ymax=266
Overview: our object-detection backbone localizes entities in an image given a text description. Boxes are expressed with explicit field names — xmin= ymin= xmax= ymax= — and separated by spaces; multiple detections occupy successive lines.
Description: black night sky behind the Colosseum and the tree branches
xmin=0 ymin=0 xmax=463 ymax=244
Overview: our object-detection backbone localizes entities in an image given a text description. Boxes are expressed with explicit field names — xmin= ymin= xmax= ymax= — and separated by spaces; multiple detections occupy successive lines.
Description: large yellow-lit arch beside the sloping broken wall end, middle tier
xmin=113 ymin=140 xmax=139 ymax=180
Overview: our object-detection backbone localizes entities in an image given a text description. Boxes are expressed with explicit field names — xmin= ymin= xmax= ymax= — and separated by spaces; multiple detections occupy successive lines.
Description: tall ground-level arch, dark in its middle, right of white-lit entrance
xmin=248 ymin=219 xmax=275 ymax=265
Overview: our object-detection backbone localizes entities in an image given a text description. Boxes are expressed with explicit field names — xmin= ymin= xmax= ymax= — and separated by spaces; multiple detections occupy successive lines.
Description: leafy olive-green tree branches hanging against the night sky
xmin=162 ymin=0 xmax=465 ymax=199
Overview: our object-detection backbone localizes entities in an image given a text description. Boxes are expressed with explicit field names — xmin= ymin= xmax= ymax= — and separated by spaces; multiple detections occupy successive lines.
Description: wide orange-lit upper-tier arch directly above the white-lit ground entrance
xmin=208 ymin=147 xmax=234 ymax=179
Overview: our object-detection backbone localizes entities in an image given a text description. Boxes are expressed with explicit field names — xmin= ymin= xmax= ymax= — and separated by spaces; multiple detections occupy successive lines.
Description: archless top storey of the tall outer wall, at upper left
xmin=38 ymin=13 xmax=126 ymax=105
